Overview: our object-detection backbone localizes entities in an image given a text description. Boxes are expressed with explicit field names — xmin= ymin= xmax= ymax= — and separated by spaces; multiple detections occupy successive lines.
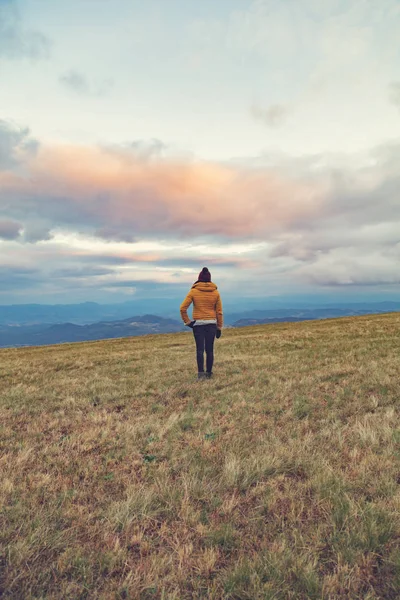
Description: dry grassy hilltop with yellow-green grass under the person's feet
xmin=0 ymin=314 xmax=400 ymax=600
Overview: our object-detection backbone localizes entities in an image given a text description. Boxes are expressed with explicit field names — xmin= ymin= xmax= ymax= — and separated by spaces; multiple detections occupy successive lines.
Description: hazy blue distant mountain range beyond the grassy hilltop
xmin=0 ymin=302 xmax=400 ymax=348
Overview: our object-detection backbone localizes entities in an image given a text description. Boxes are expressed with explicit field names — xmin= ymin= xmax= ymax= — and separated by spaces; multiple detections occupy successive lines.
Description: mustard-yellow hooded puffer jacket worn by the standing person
xmin=181 ymin=281 xmax=223 ymax=329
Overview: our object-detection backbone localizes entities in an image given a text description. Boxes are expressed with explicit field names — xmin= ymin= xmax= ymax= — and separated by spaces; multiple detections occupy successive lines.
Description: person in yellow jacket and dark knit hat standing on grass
xmin=180 ymin=267 xmax=223 ymax=379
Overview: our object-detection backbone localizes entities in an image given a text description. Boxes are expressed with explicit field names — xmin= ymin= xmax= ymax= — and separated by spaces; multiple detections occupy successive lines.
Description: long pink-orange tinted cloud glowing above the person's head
xmin=0 ymin=142 xmax=323 ymax=239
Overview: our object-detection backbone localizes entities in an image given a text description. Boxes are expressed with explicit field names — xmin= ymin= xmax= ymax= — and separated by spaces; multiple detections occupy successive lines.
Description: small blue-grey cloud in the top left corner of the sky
xmin=0 ymin=0 xmax=50 ymax=60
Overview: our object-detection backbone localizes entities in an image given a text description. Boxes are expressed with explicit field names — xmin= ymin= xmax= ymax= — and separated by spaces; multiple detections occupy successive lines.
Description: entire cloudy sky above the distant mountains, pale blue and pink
xmin=0 ymin=0 xmax=400 ymax=304
